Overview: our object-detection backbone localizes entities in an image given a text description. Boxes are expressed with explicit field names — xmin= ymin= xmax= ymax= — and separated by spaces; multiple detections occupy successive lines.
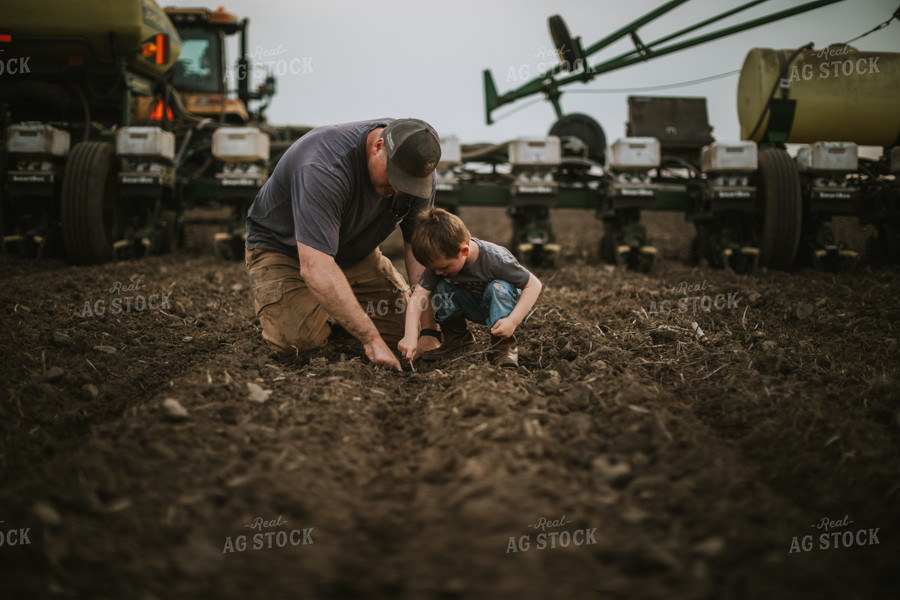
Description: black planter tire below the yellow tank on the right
xmin=757 ymin=147 xmax=803 ymax=270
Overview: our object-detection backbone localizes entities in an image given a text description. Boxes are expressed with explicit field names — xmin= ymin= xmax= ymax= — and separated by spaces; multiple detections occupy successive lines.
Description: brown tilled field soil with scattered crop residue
xmin=0 ymin=208 xmax=900 ymax=600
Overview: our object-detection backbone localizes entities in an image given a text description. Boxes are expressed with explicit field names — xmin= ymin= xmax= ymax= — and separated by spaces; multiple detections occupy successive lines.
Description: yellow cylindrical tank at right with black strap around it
xmin=737 ymin=46 xmax=900 ymax=146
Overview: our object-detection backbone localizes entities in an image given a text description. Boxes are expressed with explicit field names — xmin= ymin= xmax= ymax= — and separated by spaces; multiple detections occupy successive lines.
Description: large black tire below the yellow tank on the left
xmin=60 ymin=142 xmax=116 ymax=265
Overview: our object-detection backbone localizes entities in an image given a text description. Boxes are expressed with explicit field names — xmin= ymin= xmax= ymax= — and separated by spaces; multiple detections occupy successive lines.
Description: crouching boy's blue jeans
xmin=431 ymin=279 xmax=522 ymax=327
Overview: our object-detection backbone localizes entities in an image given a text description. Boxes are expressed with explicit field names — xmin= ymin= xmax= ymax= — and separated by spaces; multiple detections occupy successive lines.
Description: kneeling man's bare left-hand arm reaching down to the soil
xmin=297 ymin=242 xmax=400 ymax=370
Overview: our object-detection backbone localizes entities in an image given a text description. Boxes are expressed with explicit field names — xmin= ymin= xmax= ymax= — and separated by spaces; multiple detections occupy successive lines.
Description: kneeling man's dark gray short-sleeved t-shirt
xmin=247 ymin=119 xmax=434 ymax=267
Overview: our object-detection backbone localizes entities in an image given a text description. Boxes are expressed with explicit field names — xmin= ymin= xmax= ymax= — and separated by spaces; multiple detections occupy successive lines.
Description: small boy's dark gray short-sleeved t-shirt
xmin=419 ymin=237 xmax=531 ymax=298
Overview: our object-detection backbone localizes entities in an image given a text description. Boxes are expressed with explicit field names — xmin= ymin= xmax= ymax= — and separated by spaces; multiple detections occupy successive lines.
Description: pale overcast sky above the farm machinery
xmin=160 ymin=0 xmax=900 ymax=143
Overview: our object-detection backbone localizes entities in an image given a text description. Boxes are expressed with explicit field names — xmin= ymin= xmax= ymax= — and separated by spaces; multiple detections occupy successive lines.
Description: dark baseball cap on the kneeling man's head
xmin=384 ymin=119 xmax=441 ymax=198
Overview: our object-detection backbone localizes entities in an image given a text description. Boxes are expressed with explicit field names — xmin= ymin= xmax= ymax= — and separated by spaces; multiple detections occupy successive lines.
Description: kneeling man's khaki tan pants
xmin=244 ymin=248 xmax=409 ymax=352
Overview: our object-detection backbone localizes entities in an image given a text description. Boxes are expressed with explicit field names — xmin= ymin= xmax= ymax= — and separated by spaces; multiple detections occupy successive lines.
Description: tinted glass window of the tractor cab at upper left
xmin=172 ymin=28 xmax=223 ymax=93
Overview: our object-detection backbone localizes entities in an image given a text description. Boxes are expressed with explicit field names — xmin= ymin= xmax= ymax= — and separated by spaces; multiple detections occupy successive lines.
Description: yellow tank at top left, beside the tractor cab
xmin=0 ymin=0 xmax=181 ymax=77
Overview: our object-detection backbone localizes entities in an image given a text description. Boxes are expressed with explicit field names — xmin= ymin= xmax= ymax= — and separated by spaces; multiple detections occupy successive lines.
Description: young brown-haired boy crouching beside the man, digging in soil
xmin=398 ymin=208 xmax=542 ymax=368
